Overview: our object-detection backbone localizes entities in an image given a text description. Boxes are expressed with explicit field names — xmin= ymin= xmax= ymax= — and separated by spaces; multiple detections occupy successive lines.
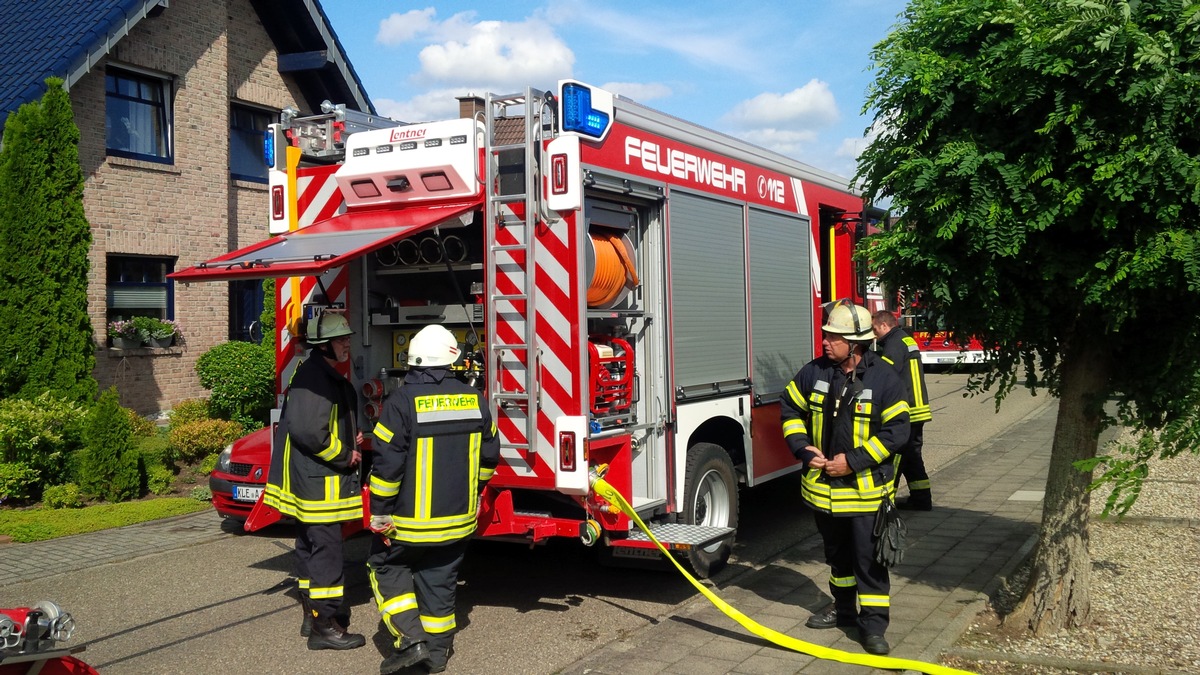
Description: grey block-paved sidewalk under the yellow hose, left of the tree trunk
xmin=562 ymin=405 xmax=1057 ymax=675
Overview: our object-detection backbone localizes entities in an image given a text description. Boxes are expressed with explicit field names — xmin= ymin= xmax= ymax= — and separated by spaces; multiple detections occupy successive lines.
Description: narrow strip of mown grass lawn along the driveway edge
xmin=0 ymin=497 xmax=212 ymax=543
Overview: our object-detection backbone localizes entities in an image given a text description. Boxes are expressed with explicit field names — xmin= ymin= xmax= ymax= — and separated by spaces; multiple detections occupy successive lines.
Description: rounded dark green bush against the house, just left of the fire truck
xmin=196 ymin=341 xmax=275 ymax=430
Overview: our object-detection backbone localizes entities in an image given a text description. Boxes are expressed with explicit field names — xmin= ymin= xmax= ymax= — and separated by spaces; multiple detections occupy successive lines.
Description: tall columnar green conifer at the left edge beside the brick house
xmin=0 ymin=78 xmax=96 ymax=404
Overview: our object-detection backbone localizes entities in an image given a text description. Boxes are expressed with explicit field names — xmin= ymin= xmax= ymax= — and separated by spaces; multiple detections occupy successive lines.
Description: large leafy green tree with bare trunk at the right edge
xmin=859 ymin=0 xmax=1200 ymax=633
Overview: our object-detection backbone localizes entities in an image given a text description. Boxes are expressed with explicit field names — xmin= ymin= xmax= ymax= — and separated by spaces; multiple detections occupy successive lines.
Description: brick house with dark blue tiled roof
xmin=0 ymin=0 xmax=374 ymax=414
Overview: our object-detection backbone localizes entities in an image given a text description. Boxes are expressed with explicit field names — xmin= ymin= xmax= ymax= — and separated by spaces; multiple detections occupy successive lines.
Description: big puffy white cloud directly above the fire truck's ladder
xmin=416 ymin=14 xmax=575 ymax=90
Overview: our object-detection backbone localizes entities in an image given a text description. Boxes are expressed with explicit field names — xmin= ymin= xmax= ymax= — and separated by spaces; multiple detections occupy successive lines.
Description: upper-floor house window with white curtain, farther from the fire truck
xmin=104 ymin=68 xmax=174 ymax=163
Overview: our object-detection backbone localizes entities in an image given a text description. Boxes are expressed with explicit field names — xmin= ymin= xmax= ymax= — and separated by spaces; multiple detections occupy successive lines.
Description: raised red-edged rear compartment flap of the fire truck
xmin=168 ymin=199 xmax=480 ymax=282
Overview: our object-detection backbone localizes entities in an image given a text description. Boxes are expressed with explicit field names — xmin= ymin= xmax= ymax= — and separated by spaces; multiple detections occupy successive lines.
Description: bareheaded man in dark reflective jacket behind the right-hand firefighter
xmin=871 ymin=310 xmax=934 ymax=510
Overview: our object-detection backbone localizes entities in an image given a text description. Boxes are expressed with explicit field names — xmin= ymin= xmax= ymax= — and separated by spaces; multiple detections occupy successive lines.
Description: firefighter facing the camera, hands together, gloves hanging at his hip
xmin=781 ymin=300 xmax=908 ymax=655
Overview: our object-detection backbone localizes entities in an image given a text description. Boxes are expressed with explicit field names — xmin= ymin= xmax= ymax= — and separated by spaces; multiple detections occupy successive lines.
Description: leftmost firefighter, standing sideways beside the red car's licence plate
xmin=263 ymin=311 xmax=366 ymax=650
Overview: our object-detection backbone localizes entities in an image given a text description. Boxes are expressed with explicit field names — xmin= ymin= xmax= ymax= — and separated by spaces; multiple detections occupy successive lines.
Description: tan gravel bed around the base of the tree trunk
xmin=947 ymin=444 xmax=1200 ymax=675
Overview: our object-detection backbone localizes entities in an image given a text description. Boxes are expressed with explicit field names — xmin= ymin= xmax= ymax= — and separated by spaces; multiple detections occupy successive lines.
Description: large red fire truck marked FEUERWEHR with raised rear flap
xmin=187 ymin=80 xmax=883 ymax=575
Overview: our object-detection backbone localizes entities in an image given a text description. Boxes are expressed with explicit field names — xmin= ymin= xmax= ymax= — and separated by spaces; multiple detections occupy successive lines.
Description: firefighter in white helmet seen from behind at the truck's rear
xmin=367 ymin=324 xmax=500 ymax=675
